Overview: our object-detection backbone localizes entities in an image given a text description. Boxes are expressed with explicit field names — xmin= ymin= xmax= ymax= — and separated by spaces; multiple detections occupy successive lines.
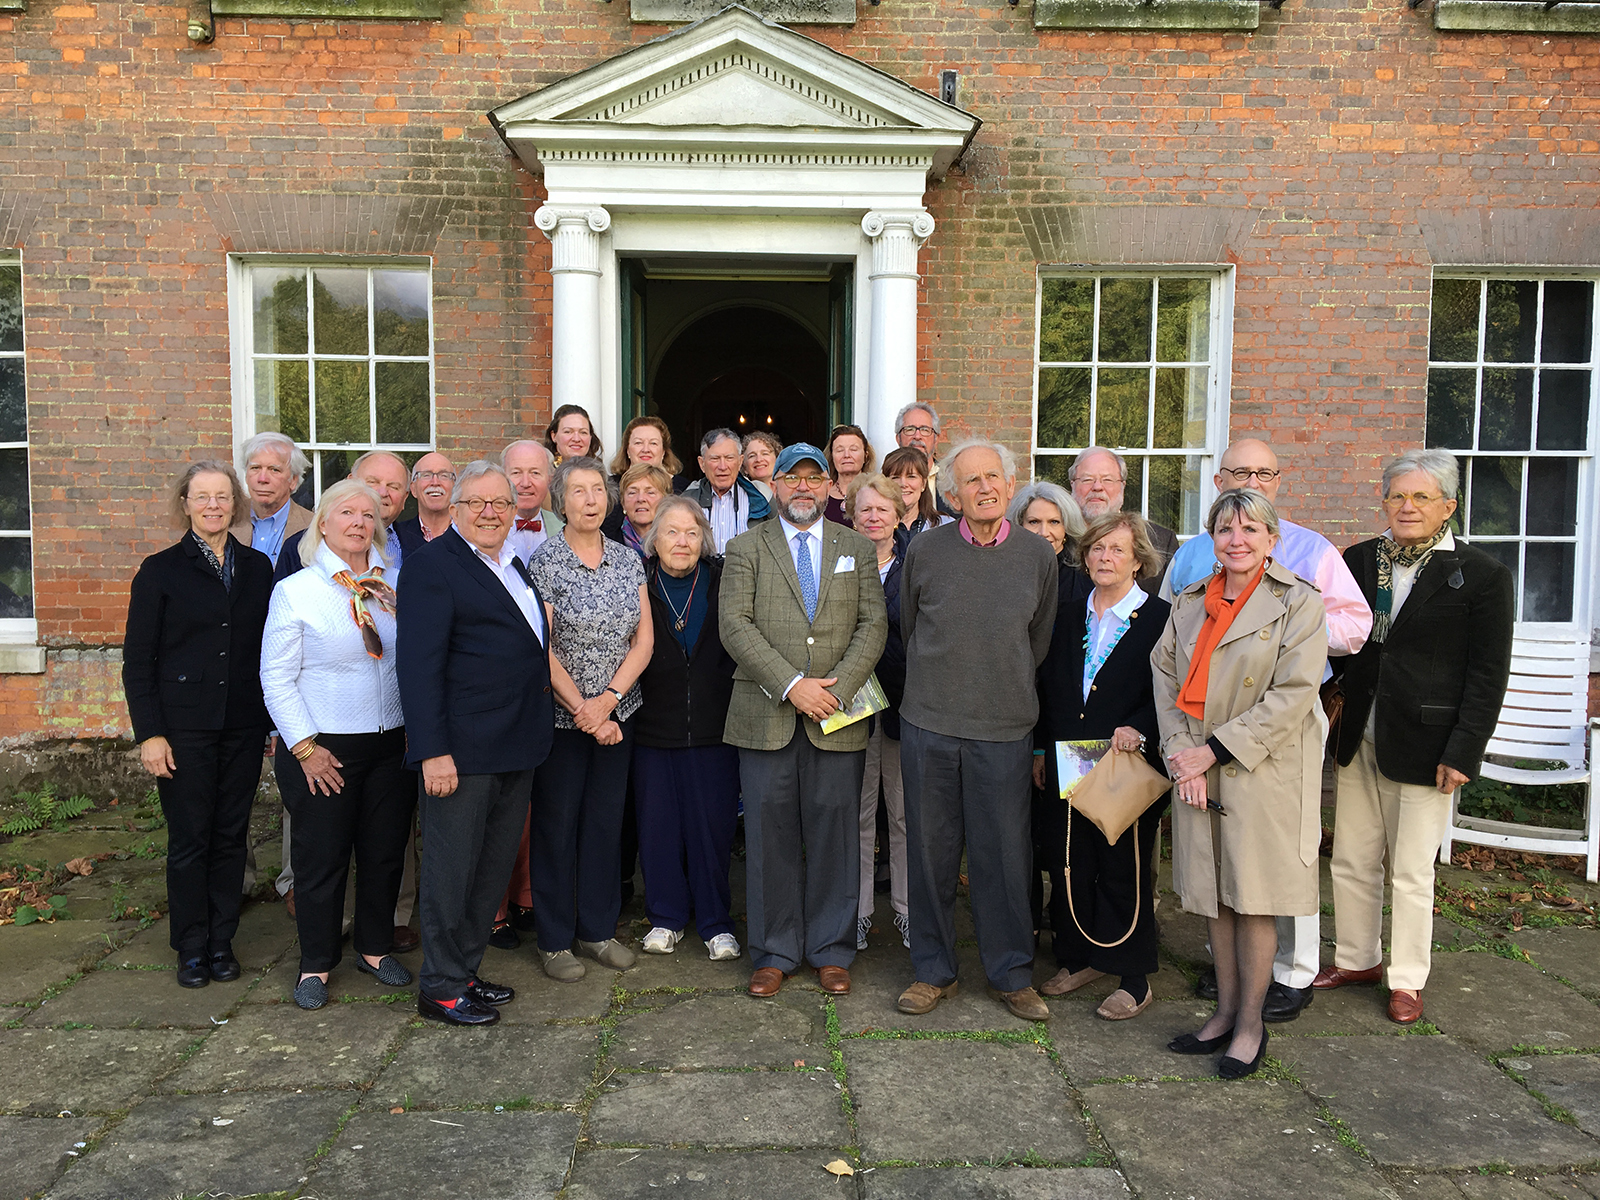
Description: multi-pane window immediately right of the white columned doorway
xmin=1034 ymin=272 xmax=1222 ymax=534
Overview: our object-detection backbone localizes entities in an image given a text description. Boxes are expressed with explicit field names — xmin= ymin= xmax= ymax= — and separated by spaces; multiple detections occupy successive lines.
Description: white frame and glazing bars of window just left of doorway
xmin=227 ymin=254 xmax=438 ymax=496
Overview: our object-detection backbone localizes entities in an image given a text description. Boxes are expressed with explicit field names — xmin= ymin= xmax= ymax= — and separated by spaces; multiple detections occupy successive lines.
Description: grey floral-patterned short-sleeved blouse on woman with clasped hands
xmin=528 ymin=534 xmax=645 ymax=730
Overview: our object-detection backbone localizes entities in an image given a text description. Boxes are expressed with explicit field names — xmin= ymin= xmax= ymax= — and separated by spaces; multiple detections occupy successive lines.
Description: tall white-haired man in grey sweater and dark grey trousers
xmin=899 ymin=442 xmax=1058 ymax=1021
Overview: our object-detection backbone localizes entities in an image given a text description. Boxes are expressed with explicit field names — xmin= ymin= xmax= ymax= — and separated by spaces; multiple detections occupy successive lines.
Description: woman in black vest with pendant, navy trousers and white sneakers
xmin=634 ymin=496 xmax=739 ymax=962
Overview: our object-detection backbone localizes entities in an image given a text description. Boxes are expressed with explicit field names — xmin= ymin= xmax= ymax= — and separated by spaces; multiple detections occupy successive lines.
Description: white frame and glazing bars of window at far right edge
xmin=1424 ymin=266 xmax=1600 ymax=642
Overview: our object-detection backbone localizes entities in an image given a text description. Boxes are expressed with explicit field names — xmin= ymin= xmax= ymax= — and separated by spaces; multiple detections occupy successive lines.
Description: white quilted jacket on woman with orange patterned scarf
xmin=261 ymin=544 xmax=405 ymax=746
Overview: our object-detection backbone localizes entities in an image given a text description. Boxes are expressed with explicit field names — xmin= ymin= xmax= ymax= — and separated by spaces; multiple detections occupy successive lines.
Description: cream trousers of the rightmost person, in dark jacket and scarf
xmin=1333 ymin=739 xmax=1450 ymax=992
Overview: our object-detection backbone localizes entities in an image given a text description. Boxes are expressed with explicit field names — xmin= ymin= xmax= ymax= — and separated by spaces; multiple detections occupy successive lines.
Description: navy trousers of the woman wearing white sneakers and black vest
xmin=634 ymin=746 xmax=739 ymax=941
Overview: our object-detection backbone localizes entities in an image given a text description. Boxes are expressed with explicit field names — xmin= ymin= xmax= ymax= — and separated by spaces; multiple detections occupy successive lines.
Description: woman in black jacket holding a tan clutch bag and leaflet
xmin=1034 ymin=512 xmax=1171 ymax=1021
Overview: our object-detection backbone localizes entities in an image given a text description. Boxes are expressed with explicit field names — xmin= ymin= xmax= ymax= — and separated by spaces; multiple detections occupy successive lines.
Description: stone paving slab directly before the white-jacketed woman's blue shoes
xmin=162 ymin=1003 xmax=414 ymax=1091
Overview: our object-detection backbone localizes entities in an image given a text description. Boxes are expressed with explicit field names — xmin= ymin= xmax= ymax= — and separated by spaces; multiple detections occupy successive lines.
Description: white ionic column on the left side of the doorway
xmin=533 ymin=205 xmax=611 ymax=429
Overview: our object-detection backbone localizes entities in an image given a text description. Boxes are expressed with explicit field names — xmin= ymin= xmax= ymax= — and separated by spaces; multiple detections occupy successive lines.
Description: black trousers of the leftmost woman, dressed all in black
xmin=155 ymin=725 xmax=267 ymax=958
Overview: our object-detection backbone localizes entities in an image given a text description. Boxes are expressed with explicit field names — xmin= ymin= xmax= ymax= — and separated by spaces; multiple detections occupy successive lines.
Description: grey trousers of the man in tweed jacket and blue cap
xmin=736 ymin=717 xmax=867 ymax=973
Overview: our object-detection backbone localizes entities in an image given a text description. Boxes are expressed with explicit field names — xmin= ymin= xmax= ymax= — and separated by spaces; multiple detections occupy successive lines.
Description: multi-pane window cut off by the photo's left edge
xmin=0 ymin=258 xmax=34 ymax=624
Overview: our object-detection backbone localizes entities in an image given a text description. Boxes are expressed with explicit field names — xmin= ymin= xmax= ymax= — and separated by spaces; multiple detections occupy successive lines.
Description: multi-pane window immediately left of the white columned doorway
xmin=245 ymin=262 xmax=434 ymax=501
